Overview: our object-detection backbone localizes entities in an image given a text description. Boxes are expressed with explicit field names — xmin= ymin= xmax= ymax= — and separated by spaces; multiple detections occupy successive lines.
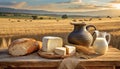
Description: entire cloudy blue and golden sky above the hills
xmin=0 ymin=0 xmax=120 ymax=12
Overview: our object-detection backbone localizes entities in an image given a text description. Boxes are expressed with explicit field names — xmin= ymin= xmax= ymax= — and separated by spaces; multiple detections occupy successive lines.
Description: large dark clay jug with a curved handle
xmin=68 ymin=22 xmax=96 ymax=47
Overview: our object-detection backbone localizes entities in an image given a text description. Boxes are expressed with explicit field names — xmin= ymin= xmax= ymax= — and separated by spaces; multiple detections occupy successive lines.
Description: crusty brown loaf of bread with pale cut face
xmin=8 ymin=38 xmax=40 ymax=56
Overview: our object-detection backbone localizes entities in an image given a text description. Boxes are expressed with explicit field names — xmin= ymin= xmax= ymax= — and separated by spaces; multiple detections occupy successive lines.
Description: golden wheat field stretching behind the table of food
xmin=0 ymin=17 xmax=120 ymax=49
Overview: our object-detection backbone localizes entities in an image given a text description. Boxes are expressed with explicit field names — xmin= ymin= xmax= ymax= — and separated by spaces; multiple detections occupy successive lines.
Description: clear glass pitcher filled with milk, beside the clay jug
xmin=93 ymin=30 xmax=111 ymax=54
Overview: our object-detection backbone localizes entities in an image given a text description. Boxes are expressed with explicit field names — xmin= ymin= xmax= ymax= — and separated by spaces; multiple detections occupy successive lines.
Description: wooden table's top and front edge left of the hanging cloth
xmin=0 ymin=50 xmax=61 ymax=67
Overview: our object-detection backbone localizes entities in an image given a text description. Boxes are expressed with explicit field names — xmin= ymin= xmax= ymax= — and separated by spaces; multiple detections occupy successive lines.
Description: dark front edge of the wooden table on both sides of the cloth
xmin=0 ymin=61 xmax=120 ymax=67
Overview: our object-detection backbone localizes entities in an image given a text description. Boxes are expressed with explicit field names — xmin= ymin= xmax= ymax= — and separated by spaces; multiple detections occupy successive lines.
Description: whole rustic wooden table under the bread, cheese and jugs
xmin=0 ymin=48 xmax=120 ymax=69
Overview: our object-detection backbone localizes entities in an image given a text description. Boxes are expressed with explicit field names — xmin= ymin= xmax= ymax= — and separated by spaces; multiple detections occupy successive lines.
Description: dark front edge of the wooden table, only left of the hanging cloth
xmin=0 ymin=62 xmax=59 ymax=67
